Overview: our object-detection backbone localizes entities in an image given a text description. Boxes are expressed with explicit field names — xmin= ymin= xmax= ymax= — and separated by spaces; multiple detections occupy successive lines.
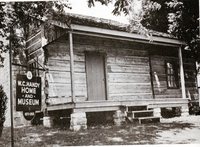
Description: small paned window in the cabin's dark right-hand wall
xmin=166 ymin=62 xmax=179 ymax=88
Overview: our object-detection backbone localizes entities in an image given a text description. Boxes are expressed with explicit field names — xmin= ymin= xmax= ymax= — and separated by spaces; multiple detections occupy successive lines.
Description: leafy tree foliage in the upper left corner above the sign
xmin=0 ymin=1 xmax=70 ymax=64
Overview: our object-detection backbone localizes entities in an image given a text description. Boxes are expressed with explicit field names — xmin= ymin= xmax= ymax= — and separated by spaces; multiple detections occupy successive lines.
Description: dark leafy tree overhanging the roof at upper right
xmin=88 ymin=0 xmax=200 ymax=62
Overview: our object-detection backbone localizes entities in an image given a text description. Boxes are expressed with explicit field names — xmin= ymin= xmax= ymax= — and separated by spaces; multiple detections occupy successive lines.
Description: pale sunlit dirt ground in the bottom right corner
xmin=155 ymin=116 xmax=200 ymax=144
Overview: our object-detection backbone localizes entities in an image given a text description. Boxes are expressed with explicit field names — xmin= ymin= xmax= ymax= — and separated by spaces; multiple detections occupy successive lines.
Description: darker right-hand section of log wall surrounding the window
xmin=150 ymin=47 xmax=197 ymax=99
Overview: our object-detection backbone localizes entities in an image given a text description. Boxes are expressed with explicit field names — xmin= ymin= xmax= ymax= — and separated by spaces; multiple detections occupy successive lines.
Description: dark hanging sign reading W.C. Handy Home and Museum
xmin=16 ymin=74 xmax=41 ymax=111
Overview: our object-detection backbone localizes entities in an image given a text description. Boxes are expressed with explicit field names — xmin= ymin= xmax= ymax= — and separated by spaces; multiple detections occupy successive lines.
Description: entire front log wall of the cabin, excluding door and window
xmin=46 ymin=35 xmax=196 ymax=103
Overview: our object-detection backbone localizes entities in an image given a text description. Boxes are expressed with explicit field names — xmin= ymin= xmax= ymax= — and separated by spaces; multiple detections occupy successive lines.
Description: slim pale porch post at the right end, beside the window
xmin=178 ymin=47 xmax=186 ymax=99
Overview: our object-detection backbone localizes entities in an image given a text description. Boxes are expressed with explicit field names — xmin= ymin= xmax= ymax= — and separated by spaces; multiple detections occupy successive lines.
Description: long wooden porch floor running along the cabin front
xmin=47 ymin=98 xmax=188 ymax=112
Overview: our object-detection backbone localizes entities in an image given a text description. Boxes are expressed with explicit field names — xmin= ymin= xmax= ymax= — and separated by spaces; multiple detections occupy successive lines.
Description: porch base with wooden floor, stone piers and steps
xmin=43 ymin=98 xmax=188 ymax=131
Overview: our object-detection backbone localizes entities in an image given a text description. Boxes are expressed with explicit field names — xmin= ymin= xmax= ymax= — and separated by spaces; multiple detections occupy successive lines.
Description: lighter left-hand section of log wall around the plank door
xmin=46 ymin=35 xmax=153 ymax=104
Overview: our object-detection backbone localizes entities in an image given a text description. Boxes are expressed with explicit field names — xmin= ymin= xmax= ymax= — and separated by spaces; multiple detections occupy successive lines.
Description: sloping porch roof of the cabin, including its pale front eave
xmin=45 ymin=13 xmax=185 ymax=47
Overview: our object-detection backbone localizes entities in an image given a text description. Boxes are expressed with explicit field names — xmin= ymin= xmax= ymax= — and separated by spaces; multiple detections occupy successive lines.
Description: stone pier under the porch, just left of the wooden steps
xmin=113 ymin=110 xmax=126 ymax=126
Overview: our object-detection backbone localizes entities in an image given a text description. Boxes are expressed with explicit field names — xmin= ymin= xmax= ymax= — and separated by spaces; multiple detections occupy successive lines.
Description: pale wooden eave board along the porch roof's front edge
xmin=70 ymin=24 xmax=185 ymax=47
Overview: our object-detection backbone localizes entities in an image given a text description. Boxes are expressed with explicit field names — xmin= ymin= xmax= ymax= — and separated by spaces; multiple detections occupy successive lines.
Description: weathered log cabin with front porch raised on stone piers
xmin=1 ymin=14 xmax=197 ymax=130
